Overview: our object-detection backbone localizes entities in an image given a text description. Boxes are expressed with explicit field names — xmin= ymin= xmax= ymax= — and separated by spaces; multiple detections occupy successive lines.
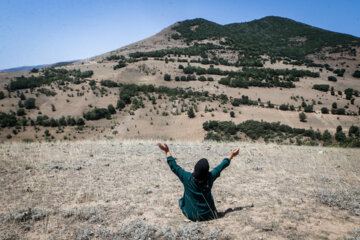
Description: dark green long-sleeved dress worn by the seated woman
xmin=167 ymin=156 xmax=230 ymax=221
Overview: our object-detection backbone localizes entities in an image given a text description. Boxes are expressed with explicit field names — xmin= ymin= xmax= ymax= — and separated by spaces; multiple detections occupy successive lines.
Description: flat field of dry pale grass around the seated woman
xmin=0 ymin=140 xmax=360 ymax=240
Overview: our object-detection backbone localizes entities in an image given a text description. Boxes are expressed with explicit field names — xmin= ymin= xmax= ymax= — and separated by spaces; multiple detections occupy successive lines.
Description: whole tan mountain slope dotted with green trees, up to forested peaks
xmin=0 ymin=17 xmax=360 ymax=147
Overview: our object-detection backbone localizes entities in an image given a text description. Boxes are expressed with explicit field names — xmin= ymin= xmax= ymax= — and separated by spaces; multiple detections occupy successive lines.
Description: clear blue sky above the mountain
xmin=0 ymin=0 xmax=360 ymax=69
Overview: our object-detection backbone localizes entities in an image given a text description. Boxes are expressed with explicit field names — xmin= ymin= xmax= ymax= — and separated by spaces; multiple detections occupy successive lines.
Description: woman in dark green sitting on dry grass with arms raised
xmin=158 ymin=143 xmax=239 ymax=221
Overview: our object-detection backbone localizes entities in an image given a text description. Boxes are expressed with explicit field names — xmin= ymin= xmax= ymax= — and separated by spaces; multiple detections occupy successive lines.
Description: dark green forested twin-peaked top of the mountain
xmin=173 ymin=16 xmax=360 ymax=58
